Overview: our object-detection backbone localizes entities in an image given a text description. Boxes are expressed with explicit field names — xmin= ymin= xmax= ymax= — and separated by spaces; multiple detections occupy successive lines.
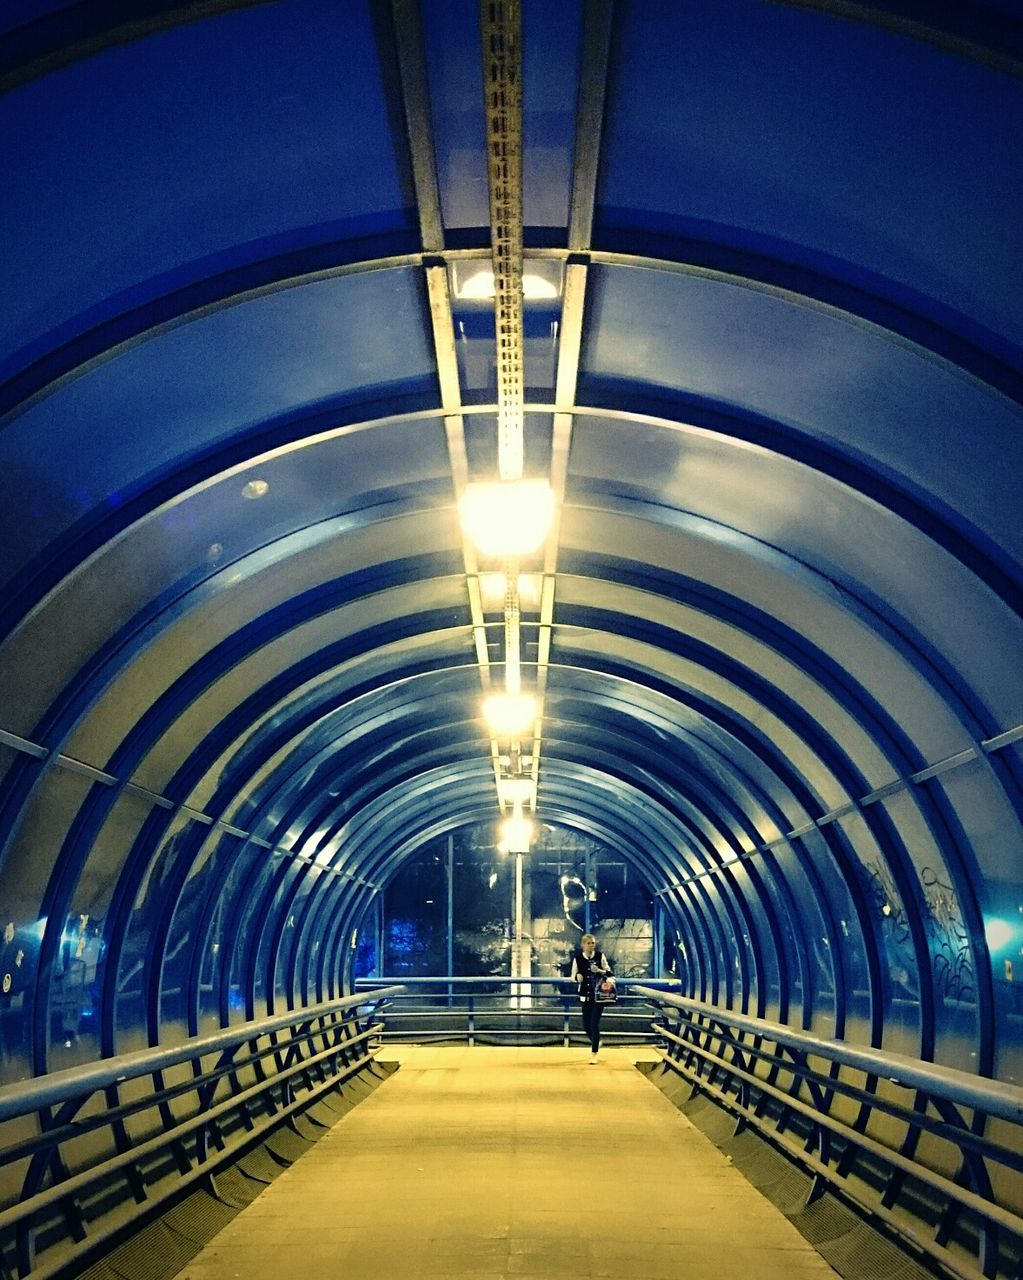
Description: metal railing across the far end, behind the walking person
xmin=356 ymin=977 xmax=679 ymax=1046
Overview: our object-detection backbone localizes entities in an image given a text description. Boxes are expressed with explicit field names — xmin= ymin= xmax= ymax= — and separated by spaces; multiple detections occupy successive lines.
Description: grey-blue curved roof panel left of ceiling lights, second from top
xmin=0 ymin=270 xmax=434 ymax=596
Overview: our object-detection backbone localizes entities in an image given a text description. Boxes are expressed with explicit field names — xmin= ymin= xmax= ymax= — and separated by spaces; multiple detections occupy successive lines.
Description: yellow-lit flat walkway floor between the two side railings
xmin=171 ymin=1046 xmax=836 ymax=1280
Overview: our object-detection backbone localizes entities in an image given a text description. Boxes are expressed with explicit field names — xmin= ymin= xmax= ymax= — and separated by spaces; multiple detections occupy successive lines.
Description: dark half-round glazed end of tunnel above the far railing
xmin=356 ymin=823 xmax=659 ymax=978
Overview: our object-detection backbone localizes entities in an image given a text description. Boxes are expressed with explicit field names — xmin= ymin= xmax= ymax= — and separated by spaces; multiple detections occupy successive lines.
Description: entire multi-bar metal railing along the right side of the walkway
xmin=634 ymin=987 xmax=1023 ymax=1280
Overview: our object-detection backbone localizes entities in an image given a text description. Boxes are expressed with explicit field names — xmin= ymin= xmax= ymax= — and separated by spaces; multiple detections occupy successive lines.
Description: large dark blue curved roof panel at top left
xmin=0 ymin=0 xmax=410 ymax=351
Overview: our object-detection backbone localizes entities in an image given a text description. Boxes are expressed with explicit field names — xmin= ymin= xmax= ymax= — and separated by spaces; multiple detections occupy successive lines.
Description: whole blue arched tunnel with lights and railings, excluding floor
xmin=0 ymin=0 xmax=1023 ymax=1280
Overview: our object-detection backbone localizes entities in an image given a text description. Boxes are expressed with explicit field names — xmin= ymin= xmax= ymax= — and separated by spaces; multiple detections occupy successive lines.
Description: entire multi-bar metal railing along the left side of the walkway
xmin=0 ymin=987 xmax=401 ymax=1280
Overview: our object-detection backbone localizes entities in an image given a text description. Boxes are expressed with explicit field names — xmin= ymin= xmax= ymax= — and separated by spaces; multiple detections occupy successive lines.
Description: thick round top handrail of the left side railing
xmin=0 ymin=986 xmax=401 ymax=1121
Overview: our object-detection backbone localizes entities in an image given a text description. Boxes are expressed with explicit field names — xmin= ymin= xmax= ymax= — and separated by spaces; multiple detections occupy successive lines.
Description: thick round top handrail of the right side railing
xmin=632 ymin=986 xmax=1023 ymax=1124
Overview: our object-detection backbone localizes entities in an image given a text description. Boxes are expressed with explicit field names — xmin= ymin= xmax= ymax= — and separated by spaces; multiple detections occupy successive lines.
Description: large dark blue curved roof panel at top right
xmin=599 ymin=0 xmax=1023 ymax=343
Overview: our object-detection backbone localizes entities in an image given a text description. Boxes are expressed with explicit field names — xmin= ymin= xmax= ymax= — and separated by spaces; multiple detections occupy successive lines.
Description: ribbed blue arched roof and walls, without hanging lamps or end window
xmin=0 ymin=0 xmax=1023 ymax=1078
